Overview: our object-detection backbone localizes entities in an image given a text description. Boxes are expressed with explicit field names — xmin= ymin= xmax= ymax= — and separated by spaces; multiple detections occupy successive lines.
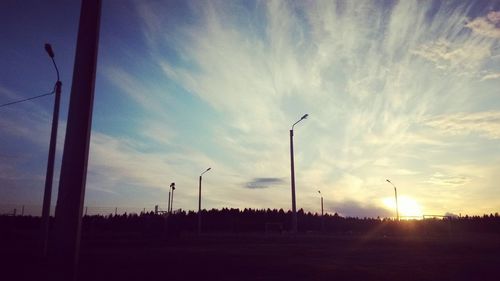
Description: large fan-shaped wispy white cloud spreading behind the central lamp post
xmin=125 ymin=1 xmax=500 ymax=214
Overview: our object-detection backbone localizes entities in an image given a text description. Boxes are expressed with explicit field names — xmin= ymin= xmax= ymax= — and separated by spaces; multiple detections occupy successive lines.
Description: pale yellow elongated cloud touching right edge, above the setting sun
xmin=425 ymin=111 xmax=500 ymax=139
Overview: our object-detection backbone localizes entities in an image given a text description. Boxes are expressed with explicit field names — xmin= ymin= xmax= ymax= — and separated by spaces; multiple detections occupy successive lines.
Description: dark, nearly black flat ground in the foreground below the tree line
xmin=0 ymin=231 xmax=500 ymax=281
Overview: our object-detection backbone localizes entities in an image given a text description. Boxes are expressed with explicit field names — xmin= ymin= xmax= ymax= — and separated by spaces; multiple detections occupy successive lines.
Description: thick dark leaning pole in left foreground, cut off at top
xmin=51 ymin=0 xmax=101 ymax=280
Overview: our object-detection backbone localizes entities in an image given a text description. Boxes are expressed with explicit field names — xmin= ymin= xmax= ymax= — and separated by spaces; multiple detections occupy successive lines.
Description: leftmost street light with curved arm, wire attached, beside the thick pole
xmin=42 ymin=44 xmax=62 ymax=256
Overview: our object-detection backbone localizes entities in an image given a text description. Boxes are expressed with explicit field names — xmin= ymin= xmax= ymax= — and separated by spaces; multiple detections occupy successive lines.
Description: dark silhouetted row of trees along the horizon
xmin=0 ymin=208 xmax=500 ymax=236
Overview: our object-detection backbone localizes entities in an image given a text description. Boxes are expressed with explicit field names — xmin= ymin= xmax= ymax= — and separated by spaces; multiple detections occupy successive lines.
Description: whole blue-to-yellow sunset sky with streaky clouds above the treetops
xmin=0 ymin=0 xmax=500 ymax=217
